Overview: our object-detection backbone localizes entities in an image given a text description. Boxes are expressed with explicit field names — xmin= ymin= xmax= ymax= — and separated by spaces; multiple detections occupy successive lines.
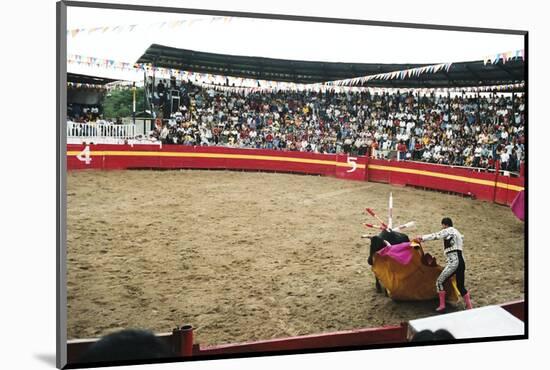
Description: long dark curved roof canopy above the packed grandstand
xmin=137 ymin=44 xmax=525 ymax=88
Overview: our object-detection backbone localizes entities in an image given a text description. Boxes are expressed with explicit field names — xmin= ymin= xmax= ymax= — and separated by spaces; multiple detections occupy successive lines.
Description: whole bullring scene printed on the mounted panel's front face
xmin=60 ymin=13 xmax=527 ymax=363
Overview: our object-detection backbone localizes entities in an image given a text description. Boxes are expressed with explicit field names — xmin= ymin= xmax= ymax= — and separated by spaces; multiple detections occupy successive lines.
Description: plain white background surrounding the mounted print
xmin=0 ymin=0 xmax=550 ymax=369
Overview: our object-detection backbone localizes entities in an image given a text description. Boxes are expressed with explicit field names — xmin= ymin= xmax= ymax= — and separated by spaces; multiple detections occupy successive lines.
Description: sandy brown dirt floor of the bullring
xmin=67 ymin=170 xmax=525 ymax=344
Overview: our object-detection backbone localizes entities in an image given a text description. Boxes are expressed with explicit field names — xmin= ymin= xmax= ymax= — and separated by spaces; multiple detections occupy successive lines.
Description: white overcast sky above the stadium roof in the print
xmin=67 ymin=8 xmax=523 ymax=64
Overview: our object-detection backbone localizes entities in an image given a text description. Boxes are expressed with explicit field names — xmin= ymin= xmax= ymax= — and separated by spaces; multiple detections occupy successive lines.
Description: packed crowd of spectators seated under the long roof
xmin=152 ymin=84 xmax=525 ymax=171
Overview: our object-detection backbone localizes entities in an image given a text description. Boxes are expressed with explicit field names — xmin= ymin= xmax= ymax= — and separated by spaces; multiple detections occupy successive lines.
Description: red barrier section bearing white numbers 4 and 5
xmin=67 ymin=144 xmax=366 ymax=181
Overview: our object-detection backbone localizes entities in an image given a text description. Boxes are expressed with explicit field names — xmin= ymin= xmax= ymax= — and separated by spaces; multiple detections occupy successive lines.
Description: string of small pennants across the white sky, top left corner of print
xmin=67 ymin=16 xmax=233 ymax=37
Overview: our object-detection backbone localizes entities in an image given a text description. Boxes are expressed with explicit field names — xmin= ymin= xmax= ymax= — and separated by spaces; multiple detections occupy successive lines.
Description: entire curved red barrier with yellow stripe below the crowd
xmin=67 ymin=144 xmax=524 ymax=205
